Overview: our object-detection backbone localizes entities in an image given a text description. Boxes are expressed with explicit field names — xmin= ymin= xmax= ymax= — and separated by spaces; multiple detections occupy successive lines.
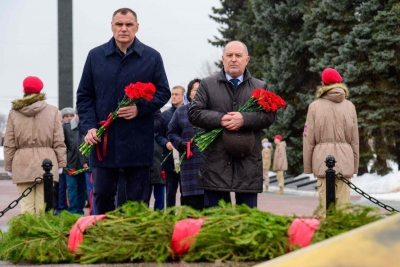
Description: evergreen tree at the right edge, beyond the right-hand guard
xmin=340 ymin=0 xmax=400 ymax=175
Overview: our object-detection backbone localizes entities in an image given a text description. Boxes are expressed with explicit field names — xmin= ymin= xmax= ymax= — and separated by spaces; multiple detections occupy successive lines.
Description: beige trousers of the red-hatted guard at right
xmin=317 ymin=177 xmax=351 ymax=216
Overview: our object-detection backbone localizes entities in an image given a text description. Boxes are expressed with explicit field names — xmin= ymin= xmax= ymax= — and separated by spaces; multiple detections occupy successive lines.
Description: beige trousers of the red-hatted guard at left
xmin=17 ymin=182 xmax=44 ymax=214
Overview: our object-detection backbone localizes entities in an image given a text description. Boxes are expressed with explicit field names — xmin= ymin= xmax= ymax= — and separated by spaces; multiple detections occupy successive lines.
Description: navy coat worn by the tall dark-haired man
xmin=76 ymin=38 xmax=171 ymax=167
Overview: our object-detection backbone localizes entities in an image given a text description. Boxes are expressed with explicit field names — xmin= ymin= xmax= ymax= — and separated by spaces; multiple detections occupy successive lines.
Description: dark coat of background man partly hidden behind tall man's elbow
xmin=155 ymin=106 xmax=176 ymax=171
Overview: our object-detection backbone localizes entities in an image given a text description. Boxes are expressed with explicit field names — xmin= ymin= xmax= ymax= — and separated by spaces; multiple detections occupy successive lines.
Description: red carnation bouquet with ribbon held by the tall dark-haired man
xmin=79 ymin=82 xmax=156 ymax=161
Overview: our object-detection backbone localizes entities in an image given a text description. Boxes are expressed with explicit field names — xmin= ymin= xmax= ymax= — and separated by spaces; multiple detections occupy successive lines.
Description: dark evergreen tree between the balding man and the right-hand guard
xmin=252 ymin=0 xmax=318 ymax=174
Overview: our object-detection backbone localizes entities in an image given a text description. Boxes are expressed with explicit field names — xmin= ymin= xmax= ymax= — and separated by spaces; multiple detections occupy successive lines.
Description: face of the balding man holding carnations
xmin=222 ymin=42 xmax=250 ymax=78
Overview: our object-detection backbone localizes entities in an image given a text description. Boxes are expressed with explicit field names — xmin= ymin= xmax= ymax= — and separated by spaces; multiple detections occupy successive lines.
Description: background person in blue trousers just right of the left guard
xmin=63 ymin=108 xmax=86 ymax=215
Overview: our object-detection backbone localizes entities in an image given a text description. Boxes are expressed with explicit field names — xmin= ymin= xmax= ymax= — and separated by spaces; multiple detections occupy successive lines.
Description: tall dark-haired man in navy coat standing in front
xmin=77 ymin=8 xmax=171 ymax=214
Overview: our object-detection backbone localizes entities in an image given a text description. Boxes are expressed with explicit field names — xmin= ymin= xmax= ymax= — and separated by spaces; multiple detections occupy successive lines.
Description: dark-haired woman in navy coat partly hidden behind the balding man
xmin=167 ymin=79 xmax=204 ymax=210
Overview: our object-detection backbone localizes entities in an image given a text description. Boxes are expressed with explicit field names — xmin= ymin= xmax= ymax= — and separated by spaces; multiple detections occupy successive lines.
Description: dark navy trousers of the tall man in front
xmin=92 ymin=166 xmax=150 ymax=214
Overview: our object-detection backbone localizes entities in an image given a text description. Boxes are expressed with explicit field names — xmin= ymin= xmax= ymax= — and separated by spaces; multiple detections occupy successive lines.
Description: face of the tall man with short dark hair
xmin=111 ymin=12 xmax=139 ymax=45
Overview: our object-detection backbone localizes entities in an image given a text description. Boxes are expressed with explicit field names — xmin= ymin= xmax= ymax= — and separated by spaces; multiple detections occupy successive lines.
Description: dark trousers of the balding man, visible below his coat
xmin=204 ymin=190 xmax=258 ymax=208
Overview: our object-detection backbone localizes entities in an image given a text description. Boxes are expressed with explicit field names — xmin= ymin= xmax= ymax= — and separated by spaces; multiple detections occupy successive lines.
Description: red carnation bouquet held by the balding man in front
xmin=194 ymin=88 xmax=286 ymax=152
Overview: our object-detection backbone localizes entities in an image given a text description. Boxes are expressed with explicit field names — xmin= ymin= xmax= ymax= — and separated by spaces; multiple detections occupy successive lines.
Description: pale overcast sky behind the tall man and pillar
xmin=0 ymin=0 xmax=222 ymax=115
